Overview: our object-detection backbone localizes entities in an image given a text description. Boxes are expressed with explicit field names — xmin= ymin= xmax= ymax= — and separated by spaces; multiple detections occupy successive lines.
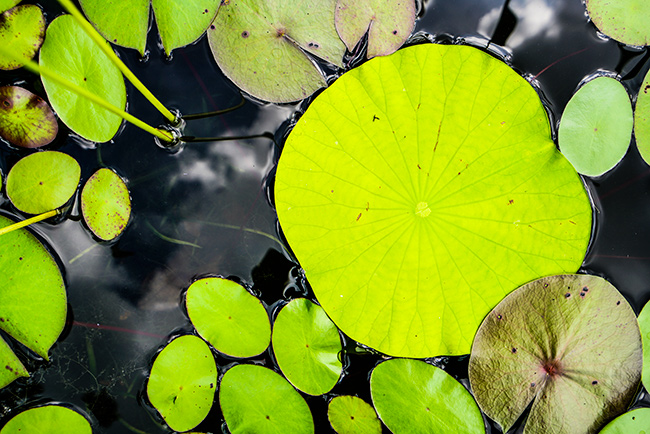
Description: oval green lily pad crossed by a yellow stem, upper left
xmin=40 ymin=15 xmax=126 ymax=142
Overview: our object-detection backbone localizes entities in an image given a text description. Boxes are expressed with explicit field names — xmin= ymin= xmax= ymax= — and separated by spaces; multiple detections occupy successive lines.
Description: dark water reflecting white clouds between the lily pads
xmin=0 ymin=0 xmax=650 ymax=433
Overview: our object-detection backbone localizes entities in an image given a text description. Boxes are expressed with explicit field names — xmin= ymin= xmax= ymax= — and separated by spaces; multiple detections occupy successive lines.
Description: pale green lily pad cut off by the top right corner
xmin=586 ymin=0 xmax=650 ymax=45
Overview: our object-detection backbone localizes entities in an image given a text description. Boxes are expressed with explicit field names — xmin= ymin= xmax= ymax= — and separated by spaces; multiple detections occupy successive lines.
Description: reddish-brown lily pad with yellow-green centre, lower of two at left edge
xmin=0 ymin=86 xmax=59 ymax=148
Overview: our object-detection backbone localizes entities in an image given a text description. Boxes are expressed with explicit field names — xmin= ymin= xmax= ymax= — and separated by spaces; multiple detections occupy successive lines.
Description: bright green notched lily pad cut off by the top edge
xmin=79 ymin=0 xmax=220 ymax=55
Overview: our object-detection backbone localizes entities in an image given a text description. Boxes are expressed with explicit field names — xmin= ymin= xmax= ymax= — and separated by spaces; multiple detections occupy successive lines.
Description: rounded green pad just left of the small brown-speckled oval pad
xmin=7 ymin=151 xmax=81 ymax=214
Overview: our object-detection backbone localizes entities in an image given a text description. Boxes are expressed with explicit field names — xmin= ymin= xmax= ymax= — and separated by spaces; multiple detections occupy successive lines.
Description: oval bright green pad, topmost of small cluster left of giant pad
xmin=185 ymin=277 xmax=271 ymax=357
